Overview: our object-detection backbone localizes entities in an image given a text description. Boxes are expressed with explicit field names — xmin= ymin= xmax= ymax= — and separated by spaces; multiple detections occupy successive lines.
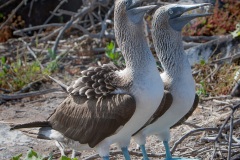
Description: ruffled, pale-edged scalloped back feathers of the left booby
xmin=67 ymin=63 xmax=127 ymax=98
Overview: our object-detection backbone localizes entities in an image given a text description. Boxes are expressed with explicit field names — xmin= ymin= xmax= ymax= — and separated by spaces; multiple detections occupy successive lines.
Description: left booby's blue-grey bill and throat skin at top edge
xmin=127 ymin=0 xmax=157 ymax=23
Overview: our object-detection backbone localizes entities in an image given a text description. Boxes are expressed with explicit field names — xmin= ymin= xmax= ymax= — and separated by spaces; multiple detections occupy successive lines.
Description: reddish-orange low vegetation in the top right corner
xmin=183 ymin=0 xmax=240 ymax=36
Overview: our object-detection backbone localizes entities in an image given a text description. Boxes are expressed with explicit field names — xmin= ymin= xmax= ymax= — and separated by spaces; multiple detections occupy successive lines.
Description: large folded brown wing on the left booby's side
xmin=48 ymin=94 xmax=136 ymax=147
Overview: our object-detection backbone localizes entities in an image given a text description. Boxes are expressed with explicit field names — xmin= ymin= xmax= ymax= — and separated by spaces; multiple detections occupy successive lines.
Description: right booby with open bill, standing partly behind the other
xmin=133 ymin=3 xmax=213 ymax=160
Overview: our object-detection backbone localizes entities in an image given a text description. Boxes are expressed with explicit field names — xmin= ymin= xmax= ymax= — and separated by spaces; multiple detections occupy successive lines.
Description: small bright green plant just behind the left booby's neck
xmin=105 ymin=41 xmax=122 ymax=65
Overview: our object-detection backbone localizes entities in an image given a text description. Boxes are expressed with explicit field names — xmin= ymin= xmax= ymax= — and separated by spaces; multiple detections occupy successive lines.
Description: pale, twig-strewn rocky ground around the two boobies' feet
xmin=0 ymin=84 xmax=240 ymax=160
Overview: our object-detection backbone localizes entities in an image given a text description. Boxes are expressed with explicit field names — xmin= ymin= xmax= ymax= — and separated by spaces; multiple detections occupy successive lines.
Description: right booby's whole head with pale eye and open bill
xmin=153 ymin=3 xmax=212 ymax=32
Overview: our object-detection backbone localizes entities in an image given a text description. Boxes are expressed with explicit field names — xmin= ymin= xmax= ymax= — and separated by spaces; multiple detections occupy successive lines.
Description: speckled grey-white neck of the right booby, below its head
xmin=153 ymin=29 xmax=191 ymax=77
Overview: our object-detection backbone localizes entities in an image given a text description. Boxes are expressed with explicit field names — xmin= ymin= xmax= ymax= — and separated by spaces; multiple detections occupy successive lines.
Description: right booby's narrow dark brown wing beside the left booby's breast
xmin=133 ymin=90 xmax=173 ymax=136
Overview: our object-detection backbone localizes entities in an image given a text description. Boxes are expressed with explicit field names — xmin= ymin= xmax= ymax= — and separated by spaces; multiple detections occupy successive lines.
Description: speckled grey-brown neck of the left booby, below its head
xmin=115 ymin=22 xmax=157 ymax=76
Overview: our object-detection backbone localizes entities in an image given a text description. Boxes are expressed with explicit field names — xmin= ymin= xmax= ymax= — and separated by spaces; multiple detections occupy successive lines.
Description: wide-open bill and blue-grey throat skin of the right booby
xmin=169 ymin=3 xmax=213 ymax=31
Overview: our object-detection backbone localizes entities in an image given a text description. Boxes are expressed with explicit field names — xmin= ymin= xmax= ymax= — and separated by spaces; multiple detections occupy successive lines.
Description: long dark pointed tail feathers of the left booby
xmin=10 ymin=121 xmax=51 ymax=130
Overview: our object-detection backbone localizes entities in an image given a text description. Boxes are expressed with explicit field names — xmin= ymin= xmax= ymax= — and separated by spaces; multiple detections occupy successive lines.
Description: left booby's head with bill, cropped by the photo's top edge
xmin=114 ymin=0 xmax=156 ymax=24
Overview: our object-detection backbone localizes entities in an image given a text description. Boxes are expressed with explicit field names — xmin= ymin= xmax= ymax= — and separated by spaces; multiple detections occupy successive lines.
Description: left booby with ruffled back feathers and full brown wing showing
xmin=9 ymin=0 xmax=163 ymax=160
